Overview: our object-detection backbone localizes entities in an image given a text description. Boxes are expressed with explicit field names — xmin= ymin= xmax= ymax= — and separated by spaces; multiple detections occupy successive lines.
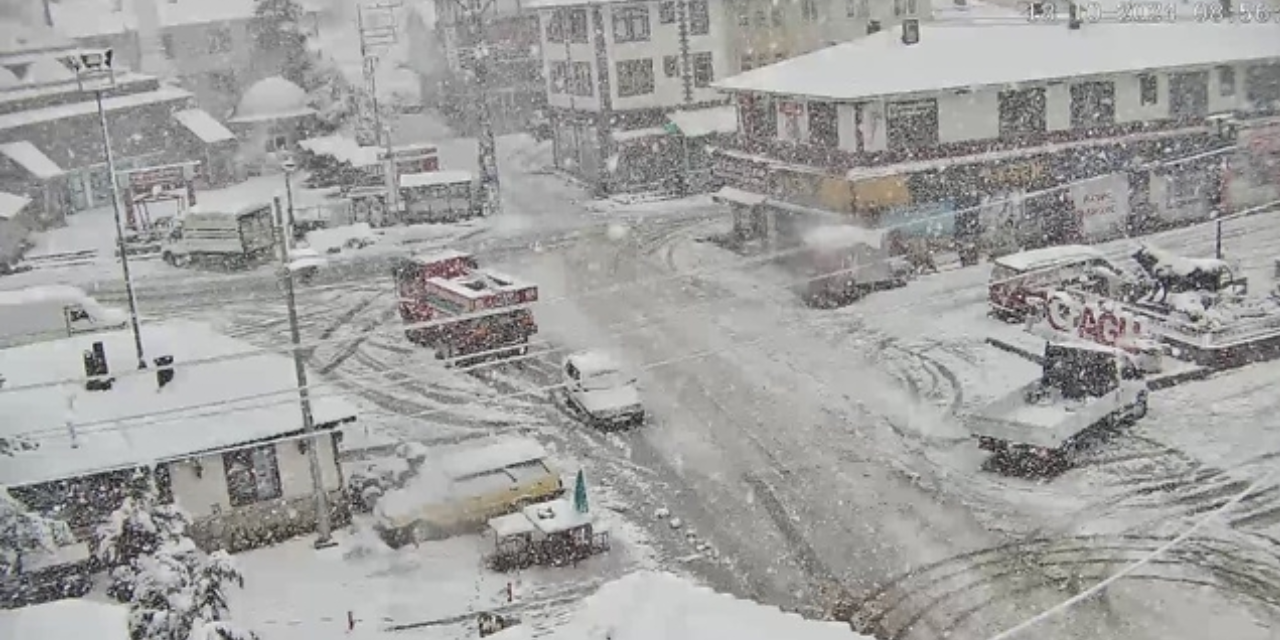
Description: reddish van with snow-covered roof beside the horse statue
xmin=987 ymin=244 xmax=1126 ymax=321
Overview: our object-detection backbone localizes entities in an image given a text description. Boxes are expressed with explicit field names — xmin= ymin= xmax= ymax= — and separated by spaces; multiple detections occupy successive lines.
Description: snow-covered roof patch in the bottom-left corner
xmin=0 ymin=598 xmax=129 ymax=640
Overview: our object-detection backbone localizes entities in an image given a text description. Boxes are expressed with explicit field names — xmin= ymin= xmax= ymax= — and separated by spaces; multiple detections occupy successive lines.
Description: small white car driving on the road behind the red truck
xmin=562 ymin=351 xmax=645 ymax=428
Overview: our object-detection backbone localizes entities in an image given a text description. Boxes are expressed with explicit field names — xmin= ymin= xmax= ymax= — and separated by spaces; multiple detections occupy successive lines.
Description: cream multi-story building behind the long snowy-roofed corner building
xmin=529 ymin=0 xmax=929 ymax=192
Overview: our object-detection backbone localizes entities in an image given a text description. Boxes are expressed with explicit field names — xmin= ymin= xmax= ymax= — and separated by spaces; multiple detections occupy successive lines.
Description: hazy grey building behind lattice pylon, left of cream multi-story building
xmin=430 ymin=0 xmax=547 ymax=133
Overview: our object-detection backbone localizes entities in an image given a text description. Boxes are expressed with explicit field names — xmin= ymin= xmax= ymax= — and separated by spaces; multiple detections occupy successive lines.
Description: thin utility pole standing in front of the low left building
xmin=271 ymin=188 xmax=338 ymax=549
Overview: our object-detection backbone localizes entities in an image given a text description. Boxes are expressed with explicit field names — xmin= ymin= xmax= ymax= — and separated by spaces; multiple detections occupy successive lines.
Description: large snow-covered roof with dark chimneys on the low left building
xmin=0 ymin=321 xmax=356 ymax=485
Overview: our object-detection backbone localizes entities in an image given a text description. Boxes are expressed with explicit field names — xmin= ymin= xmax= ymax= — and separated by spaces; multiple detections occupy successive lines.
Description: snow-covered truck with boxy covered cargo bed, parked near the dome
xmin=160 ymin=202 xmax=276 ymax=268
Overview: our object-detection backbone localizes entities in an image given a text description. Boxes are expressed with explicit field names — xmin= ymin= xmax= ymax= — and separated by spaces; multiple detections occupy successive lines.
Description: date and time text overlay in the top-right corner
xmin=1018 ymin=0 xmax=1280 ymax=24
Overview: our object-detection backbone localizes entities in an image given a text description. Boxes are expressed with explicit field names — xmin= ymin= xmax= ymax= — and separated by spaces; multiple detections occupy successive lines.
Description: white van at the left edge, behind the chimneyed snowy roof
xmin=0 ymin=284 xmax=129 ymax=348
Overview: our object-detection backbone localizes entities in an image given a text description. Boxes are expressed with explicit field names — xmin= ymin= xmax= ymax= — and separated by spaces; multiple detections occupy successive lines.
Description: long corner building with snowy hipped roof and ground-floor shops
xmin=716 ymin=20 xmax=1280 ymax=249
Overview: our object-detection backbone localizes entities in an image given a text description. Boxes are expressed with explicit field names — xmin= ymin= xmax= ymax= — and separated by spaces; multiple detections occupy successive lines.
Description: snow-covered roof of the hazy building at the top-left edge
xmin=50 ymin=0 xmax=322 ymax=38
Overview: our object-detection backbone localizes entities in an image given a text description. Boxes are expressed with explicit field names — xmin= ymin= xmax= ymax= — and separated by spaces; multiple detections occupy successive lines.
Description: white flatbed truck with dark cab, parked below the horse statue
xmin=968 ymin=340 xmax=1149 ymax=475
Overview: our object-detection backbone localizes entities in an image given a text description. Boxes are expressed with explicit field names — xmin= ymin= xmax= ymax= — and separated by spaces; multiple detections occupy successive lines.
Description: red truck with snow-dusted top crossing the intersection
xmin=394 ymin=251 xmax=538 ymax=365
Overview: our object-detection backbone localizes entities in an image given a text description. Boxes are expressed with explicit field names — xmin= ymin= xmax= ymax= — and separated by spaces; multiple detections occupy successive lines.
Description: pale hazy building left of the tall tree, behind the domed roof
xmin=49 ymin=0 xmax=317 ymax=118
